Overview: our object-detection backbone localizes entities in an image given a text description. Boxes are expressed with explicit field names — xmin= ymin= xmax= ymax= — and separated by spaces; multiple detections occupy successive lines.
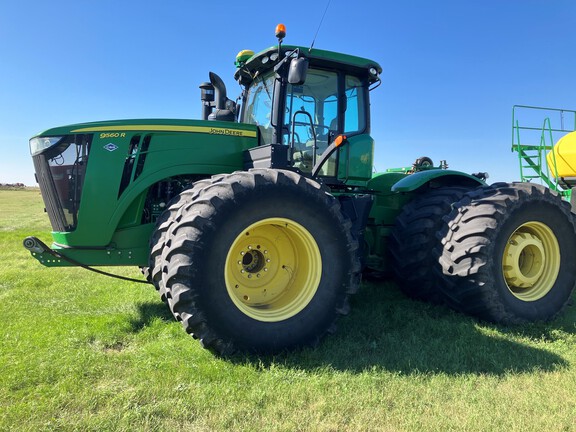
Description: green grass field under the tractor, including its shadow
xmin=0 ymin=190 xmax=576 ymax=432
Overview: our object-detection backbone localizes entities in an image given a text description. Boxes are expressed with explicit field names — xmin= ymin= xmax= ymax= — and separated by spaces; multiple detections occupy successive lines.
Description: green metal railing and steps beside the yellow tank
xmin=512 ymin=105 xmax=576 ymax=198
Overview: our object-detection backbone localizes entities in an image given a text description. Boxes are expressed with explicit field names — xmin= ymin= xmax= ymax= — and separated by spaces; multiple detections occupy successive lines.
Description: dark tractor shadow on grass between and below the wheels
xmin=237 ymin=282 xmax=574 ymax=376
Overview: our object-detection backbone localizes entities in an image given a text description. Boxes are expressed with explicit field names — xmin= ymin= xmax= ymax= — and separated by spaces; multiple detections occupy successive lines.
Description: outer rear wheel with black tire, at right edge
xmin=437 ymin=183 xmax=576 ymax=324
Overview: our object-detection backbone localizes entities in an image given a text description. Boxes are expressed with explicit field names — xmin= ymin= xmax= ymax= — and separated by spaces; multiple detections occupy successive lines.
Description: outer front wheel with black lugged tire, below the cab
xmin=162 ymin=170 xmax=360 ymax=355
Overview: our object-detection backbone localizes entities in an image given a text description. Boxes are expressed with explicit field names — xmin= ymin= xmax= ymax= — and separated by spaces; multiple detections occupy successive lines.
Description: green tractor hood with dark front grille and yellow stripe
xmin=30 ymin=119 xmax=258 ymax=238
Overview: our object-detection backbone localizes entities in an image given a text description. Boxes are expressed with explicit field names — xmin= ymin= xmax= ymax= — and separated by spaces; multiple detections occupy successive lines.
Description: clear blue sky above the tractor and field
xmin=0 ymin=0 xmax=576 ymax=185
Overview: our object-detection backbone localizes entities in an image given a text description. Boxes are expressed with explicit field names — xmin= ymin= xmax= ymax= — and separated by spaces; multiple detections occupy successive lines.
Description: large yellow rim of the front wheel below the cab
xmin=224 ymin=218 xmax=322 ymax=322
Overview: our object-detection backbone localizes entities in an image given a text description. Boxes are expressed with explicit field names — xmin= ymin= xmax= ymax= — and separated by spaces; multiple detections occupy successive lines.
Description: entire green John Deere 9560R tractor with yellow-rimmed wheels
xmin=24 ymin=26 xmax=576 ymax=355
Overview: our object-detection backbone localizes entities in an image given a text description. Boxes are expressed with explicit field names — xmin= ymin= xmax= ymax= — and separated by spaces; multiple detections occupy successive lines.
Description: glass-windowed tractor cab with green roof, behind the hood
xmin=235 ymin=44 xmax=381 ymax=185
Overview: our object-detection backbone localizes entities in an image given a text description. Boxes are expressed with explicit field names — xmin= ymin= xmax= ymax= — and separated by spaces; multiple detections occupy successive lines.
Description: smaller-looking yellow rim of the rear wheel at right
xmin=502 ymin=222 xmax=560 ymax=302
